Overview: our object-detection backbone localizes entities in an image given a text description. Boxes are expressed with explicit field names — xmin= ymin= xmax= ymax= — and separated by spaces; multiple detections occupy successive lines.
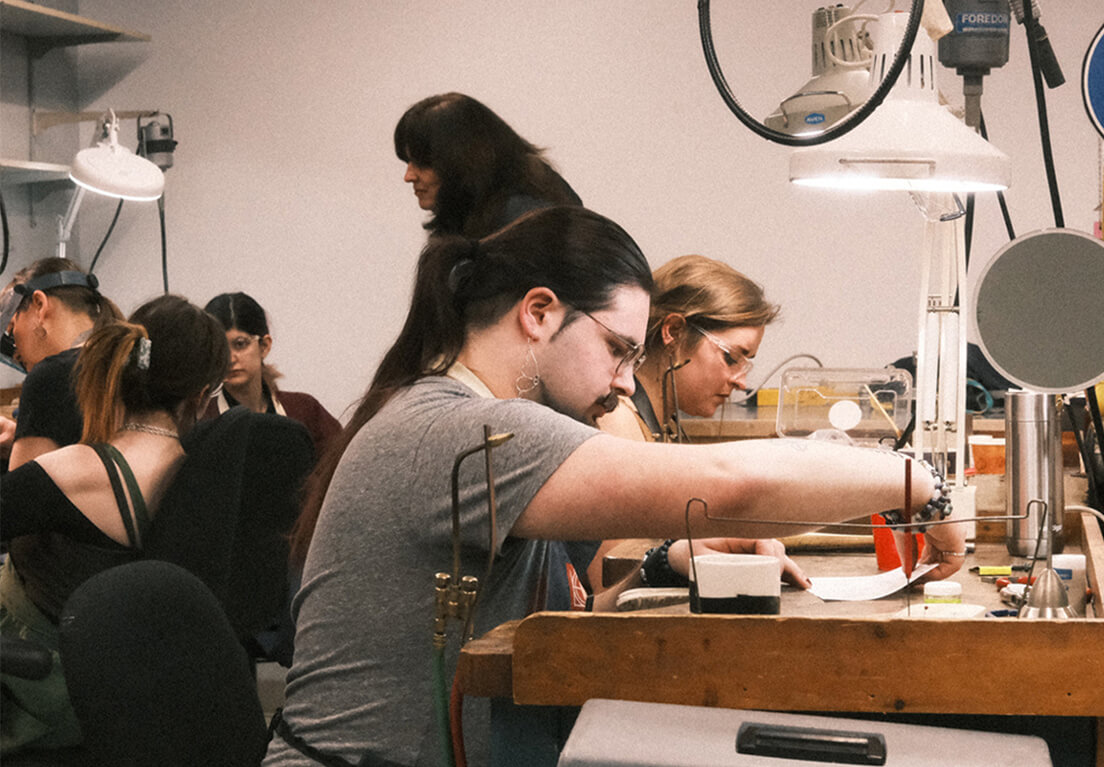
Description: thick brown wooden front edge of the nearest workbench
xmin=457 ymin=514 xmax=1104 ymax=764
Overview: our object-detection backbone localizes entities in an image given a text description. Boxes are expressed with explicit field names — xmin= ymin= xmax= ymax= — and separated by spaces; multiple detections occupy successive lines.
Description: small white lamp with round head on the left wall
xmin=57 ymin=110 xmax=164 ymax=258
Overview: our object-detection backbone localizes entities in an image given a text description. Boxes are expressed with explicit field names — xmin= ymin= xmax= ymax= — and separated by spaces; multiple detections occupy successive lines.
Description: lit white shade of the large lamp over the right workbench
xmin=789 ymin=13 xmax=1011 ymax=192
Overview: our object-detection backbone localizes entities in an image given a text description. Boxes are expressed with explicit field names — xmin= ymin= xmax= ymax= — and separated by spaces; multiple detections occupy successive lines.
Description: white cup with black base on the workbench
xmin=690 ymin=554 xmax=782 ymax=615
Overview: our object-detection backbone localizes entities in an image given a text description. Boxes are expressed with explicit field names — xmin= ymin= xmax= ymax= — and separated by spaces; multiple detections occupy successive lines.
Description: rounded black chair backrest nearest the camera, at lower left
xmin=60 ymin=561 xmax=267 ymax=767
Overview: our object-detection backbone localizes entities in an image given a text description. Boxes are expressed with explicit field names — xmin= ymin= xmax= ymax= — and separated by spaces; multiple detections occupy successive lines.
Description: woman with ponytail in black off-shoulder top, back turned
xmin=0 ymin=296 xmax=229 ymax=754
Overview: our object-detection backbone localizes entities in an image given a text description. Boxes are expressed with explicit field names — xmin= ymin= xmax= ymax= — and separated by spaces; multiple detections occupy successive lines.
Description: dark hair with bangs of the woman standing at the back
xmin=395 ymin=93 xmax=580 ymax=237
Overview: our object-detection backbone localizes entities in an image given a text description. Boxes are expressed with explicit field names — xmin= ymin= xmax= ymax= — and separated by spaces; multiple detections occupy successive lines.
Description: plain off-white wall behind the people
xmin=4 ymin=0 xmax=1104 ymax=414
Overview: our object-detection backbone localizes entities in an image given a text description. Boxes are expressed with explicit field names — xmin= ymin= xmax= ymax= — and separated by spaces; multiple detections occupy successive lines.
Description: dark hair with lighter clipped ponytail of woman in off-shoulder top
xmin=75 ymin=296 xmax=230 ymax=443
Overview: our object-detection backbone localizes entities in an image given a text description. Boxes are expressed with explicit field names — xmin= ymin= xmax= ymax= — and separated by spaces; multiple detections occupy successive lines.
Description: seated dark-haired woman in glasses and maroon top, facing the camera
xmin=203 ymin=292 xmax=341 ymax=452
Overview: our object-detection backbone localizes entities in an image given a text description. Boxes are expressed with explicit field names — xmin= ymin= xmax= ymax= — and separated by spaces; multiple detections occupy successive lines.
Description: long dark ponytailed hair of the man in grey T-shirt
xmin=291 ymin=205 xmax=652 ymax=557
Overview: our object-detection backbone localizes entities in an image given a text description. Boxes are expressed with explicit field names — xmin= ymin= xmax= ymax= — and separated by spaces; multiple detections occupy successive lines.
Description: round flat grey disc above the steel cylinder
xmin=973 ymin=228 xmax=1104 ymax=394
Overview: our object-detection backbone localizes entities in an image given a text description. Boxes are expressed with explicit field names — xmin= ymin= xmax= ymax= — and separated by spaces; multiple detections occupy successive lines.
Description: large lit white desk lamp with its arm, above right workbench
xmin=789 ymin=13 xmax=1011 ymax=510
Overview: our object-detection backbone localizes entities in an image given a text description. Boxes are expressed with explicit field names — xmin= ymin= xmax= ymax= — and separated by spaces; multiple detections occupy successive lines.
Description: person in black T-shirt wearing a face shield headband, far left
xmin=0 ymin=258 xmax=123 ymax=469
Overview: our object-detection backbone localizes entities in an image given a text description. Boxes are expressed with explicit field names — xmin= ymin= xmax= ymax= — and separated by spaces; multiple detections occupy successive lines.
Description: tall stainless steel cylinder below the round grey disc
xmin=1005 ymin=391 xmax=1065 ymax=560
